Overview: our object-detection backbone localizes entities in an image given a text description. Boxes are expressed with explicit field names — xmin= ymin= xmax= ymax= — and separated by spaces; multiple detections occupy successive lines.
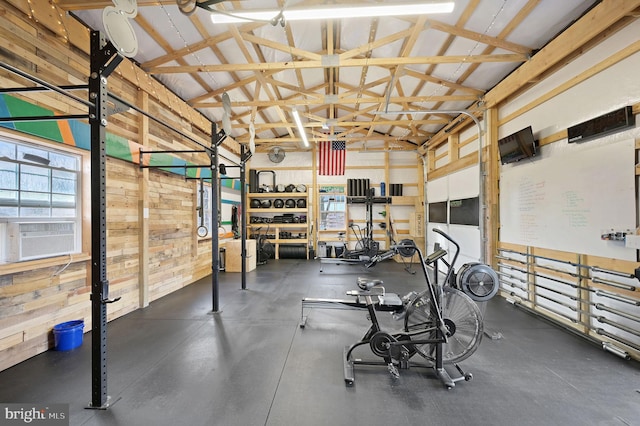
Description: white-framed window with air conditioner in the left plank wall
xmin=0 ymin=137 xmax=82 ymax=262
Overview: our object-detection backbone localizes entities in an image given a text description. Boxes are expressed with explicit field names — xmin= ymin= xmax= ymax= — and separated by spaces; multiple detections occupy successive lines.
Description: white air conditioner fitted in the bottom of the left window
xmin=6 ymin=222 xmax=77 ymax=262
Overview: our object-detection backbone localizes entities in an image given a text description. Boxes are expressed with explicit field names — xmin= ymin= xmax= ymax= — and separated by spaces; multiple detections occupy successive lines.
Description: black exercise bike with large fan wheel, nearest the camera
xmin=343 ymin=229 xmax=483 ymax=389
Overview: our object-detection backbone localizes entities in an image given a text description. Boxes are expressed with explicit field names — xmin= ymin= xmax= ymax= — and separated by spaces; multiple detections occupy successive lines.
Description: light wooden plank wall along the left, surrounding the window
xmin=0 ymin=0 xmax=218 ymax=370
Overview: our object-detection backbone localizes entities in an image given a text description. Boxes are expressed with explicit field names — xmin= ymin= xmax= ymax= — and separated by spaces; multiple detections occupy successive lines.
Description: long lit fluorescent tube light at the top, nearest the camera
xmin=211 ymin=1 xmax=454 ymax=24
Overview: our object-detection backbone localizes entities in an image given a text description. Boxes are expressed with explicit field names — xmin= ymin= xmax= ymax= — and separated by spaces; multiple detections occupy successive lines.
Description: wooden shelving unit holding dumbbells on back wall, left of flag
xmin=246 ymin=192 xmax=311 ymax=259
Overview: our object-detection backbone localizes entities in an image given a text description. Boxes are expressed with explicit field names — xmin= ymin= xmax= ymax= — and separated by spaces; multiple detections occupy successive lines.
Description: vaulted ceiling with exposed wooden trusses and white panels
xmin=54 ymin=0 xmax=597 ymax=150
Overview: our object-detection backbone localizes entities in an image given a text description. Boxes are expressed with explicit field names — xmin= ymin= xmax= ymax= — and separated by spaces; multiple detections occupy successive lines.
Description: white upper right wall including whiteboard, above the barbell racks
xmin=499 ymin=22 xmax=640 ymax=260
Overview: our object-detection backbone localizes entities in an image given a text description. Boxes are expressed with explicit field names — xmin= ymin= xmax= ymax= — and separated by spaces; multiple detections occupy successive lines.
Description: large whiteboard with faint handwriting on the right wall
xmin=500 ymin=139 xmax=636 ymax=261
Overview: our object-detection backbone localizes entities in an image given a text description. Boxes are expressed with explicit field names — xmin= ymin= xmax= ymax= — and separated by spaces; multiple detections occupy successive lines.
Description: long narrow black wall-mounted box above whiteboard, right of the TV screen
xmin=567 ymin=106 xmax=636 ymax=143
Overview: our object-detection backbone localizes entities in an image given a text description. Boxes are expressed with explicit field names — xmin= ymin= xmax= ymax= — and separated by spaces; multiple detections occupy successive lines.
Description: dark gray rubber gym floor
xmin=0 ymin=260 xmax=640 ymax=426
